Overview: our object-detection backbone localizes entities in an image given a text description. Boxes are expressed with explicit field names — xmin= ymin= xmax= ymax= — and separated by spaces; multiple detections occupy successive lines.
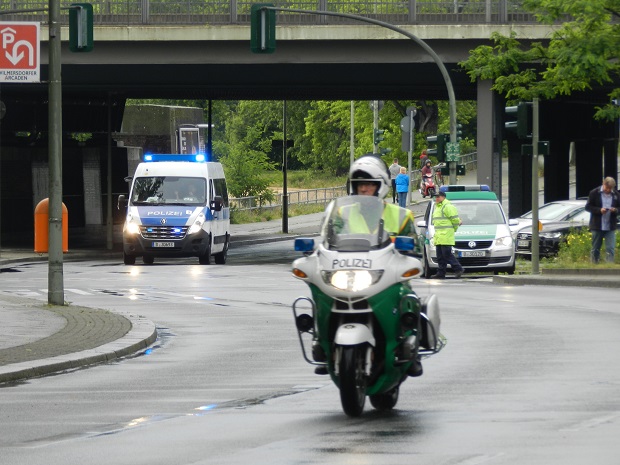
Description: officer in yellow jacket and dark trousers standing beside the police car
xmin=431 ymin=190 xmax=463 ymax=279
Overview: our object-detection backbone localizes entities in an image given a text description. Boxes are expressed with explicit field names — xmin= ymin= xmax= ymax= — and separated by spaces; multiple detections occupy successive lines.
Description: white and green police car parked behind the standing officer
xmin=416 ymin=185 xmax=516 ymax=278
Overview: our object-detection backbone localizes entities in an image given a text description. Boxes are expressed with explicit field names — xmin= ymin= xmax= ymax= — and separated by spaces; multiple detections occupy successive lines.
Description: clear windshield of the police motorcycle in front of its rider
xmin=321 ymin=195 xmax=391 ymax=252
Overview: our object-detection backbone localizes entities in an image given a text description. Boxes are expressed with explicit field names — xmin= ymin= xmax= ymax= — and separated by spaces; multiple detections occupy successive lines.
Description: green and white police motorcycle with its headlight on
xmin=293 ymin=195 xmax=446 ymax=417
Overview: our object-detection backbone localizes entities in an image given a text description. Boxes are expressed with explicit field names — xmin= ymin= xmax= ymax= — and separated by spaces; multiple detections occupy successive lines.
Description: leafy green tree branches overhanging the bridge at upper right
xmin=460 ymin=0 xmax=620 ymax=121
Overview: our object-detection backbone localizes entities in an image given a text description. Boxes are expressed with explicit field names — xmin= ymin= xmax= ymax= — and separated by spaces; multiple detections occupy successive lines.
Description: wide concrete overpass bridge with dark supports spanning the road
xmin=0 ymin=0 xmax=617 ymax=245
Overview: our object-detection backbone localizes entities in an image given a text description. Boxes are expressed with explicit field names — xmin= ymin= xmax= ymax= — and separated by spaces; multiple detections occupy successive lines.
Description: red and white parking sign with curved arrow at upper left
xmin=0 ymin=21 xmax=41 ymax=84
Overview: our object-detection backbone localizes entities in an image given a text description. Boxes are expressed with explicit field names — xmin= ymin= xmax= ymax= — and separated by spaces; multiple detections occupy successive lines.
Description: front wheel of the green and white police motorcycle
xmin=340 ymin=345 xmax=367 ymax=417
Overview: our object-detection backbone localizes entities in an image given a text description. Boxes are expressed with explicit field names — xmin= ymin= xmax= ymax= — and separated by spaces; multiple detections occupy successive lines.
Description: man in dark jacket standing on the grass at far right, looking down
xmin=586 ymin=177 xmax=620 ymax=263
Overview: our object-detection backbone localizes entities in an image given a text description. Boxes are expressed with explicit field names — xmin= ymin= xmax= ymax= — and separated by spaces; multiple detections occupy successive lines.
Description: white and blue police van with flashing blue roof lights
xmin=118 ymin=154 xmax=230 ymax=265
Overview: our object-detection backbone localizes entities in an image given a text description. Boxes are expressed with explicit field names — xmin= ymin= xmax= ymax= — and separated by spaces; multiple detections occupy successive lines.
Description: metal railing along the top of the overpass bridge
xmin=0 ymin=0 xmax=536 ymax=26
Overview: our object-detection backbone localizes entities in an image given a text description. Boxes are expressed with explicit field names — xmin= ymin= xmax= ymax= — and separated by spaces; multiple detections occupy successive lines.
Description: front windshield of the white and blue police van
xmin=131 ymin=176 xmax=206 ymax=205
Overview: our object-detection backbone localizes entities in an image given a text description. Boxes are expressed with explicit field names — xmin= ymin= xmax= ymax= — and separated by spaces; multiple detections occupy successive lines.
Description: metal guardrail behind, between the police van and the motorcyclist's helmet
xmin=229 ymin=186 xmax=347 ymax=211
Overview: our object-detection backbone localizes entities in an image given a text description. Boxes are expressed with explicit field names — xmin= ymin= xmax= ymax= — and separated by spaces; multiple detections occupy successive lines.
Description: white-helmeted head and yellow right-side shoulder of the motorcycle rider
xmin=349 ymin=154 xmax=415 ymax=236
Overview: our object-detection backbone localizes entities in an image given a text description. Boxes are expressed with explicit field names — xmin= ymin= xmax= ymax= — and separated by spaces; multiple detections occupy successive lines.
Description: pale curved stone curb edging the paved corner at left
xmin=0 ymin=313 xmax=157 ymax=383
